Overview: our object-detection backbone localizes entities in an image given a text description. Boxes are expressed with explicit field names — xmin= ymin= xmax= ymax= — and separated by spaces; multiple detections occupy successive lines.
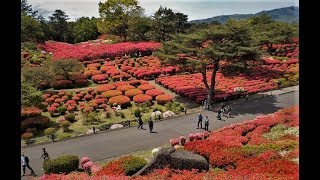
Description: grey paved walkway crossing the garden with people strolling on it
xmin=21 ymin=88 xmax=299 ymax=175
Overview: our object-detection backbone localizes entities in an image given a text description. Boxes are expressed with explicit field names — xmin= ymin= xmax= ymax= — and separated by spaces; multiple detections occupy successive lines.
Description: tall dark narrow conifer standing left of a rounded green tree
xmin=49 ymin=9 xmax=69 ymax=41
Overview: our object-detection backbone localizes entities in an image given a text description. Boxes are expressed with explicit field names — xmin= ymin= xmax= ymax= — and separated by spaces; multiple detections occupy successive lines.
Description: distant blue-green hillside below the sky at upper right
xmin=190 ymin=6 xmax=299 ymax=23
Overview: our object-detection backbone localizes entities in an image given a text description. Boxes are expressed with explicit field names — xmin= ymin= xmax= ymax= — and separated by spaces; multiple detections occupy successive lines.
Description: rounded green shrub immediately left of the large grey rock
xmin=123 ymin=156 xmax=147 ymax=176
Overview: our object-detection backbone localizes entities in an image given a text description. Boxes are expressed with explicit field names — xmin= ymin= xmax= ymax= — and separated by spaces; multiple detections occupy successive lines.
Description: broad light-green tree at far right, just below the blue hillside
xmin=251 ymin=14 xmax=294 ymax=54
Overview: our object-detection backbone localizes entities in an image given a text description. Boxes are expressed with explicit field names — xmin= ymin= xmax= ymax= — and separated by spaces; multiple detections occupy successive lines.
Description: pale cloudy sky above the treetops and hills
xmin=27 ymin=0 xmax=299 ymax=21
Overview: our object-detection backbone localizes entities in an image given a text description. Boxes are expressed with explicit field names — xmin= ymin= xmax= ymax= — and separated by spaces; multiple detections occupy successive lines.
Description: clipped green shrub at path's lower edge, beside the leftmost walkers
xmin=43 ymin=155 xmax=79 ymax=174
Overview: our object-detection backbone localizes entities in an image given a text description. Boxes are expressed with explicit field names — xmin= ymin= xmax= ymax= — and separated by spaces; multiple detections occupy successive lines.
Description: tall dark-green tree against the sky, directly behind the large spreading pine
xmin=152 ymin=7 xmax=190 ymax=41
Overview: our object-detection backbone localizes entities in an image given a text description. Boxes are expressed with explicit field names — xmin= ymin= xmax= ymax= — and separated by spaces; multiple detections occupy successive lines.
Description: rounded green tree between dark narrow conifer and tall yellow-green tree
xmin=73 ymin=17 xmax=100 ymax=43
